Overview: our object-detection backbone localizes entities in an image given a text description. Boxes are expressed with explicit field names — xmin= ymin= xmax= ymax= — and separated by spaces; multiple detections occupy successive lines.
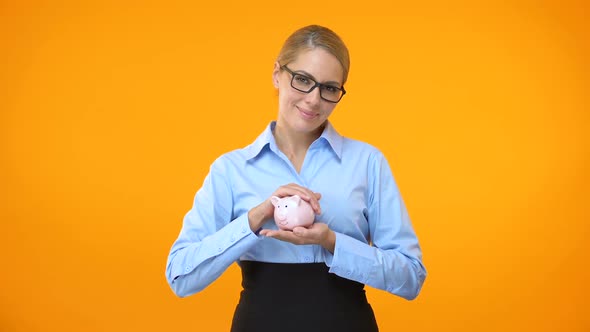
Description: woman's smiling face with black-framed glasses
xmin=273 ymin=48 xmax=344 ymax=133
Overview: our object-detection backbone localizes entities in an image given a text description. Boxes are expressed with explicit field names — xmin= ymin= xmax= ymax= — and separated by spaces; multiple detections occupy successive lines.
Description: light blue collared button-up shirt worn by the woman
xmin=166 ymin=122 xmax=426 ymax=299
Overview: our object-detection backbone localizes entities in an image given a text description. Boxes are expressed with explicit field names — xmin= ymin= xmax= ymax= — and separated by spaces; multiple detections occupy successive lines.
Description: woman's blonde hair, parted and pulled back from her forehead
xmin=277 ymin=25 xmax=350 ymax=85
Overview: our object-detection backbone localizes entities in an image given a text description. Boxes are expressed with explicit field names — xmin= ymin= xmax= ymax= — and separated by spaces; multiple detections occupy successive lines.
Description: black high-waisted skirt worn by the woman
xmin=231 ymin=261 xmax=379 ymax=332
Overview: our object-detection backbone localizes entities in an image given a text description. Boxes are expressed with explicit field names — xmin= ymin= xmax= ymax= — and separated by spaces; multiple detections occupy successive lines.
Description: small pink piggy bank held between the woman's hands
xmin=270 ymin=195 xmax=315 ymax=231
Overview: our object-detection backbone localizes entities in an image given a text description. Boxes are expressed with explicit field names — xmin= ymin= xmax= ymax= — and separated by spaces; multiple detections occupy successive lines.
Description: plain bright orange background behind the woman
xmin=0 ymin=1 xmax=590 ymax=331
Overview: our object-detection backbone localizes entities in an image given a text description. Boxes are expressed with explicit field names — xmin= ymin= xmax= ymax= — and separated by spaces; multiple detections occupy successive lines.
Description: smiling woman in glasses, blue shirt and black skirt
xmin=166 ymin=26 xmax=426 ymax=332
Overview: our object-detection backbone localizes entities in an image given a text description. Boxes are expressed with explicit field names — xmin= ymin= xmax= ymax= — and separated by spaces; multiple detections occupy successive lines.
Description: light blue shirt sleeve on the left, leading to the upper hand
xmin=166 ymin=160 xmax=258 ymax=297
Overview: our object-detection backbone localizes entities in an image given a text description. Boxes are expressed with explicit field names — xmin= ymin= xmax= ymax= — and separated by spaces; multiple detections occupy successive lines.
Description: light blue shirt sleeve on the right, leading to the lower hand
xmin=326 ymin=154 xmax=426 ymax=300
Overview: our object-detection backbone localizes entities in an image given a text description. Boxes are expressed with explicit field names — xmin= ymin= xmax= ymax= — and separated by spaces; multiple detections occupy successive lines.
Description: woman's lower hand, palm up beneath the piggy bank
xmin=260 ymin=222 xmax=336 ymax=253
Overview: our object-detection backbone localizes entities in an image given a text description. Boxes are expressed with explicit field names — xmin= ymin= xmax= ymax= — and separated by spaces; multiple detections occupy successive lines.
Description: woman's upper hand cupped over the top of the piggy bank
xmin=248 ymin=183 xmax=322 ymax=232
